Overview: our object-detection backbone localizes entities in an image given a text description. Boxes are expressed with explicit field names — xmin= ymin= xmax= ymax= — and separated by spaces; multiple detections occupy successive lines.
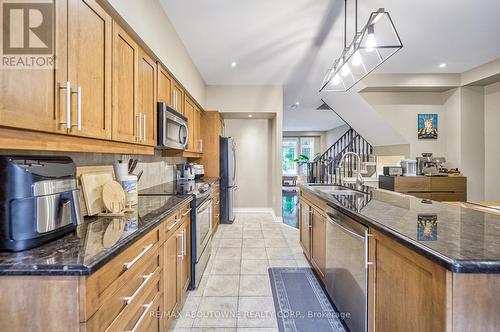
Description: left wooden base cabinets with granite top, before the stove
xmin=0 ymin=196 xmax=192 ymax=331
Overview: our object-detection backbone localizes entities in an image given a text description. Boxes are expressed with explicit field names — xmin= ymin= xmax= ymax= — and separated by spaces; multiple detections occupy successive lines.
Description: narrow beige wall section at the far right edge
xmin=484 ymin=83 xmax=500 ymax=201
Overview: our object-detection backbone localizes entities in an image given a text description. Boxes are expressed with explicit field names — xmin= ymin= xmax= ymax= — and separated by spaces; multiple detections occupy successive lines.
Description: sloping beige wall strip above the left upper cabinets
xmin=105 ymin=0 xmax=206 ymax=106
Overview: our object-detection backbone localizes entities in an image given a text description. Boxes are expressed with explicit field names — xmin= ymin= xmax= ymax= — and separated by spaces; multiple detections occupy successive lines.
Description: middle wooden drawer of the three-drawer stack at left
xmin=86 ymin=250 xmax=163 ymax=331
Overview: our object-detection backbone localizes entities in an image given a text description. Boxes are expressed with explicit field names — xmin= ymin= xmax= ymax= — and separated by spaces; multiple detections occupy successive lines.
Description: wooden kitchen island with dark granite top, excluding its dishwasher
xmin=300 ymin=184 xmax=500 ymax=331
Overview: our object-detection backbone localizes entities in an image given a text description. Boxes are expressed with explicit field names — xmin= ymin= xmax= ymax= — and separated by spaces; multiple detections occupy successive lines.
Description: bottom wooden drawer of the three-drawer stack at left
xmin=106 ymin=274 xmax=163 ymax=332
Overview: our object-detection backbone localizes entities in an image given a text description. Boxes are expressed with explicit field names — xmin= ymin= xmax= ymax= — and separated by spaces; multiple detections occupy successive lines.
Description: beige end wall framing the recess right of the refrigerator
xmin=205 ymin=85 xmax=283 ymax=217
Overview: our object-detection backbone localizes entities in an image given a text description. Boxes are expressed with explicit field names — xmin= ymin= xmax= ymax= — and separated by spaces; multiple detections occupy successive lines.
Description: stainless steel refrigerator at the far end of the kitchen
xmin=220 ymin=137 xmax=237 ymax=224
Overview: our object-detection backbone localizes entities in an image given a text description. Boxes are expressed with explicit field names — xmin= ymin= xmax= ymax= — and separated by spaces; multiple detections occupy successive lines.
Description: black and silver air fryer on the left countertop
xmin=0 ymin=156 xmax=83 ymax=251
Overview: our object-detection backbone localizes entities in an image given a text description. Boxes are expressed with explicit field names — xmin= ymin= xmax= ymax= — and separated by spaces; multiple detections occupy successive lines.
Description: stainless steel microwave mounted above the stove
xmin=158 ymin=102 xmax=189 ymax=150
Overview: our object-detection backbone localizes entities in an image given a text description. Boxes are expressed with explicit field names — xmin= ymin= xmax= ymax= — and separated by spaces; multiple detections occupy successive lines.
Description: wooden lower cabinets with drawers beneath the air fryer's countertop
xmin=0 ymin=201 xmax=191 ymax=332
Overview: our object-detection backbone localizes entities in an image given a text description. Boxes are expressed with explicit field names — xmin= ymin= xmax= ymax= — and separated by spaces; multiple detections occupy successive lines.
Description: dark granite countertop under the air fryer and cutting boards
xmin=0 ymin=196 xmax=192 ymax=276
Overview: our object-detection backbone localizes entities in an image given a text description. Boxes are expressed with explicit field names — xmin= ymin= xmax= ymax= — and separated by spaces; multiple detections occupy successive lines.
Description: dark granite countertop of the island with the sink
xmin=301 ymin=184 xmax=500 ymax=273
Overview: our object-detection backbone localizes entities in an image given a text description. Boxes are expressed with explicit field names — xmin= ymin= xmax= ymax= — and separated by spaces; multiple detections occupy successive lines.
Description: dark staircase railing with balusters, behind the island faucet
xmin=307 ymin=128 xmax=376 ymax=183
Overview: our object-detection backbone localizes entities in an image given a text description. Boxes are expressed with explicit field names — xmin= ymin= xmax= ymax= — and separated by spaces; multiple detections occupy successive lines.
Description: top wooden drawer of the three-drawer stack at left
xmin=82 ymin=227 xmax=160 ymax=320
